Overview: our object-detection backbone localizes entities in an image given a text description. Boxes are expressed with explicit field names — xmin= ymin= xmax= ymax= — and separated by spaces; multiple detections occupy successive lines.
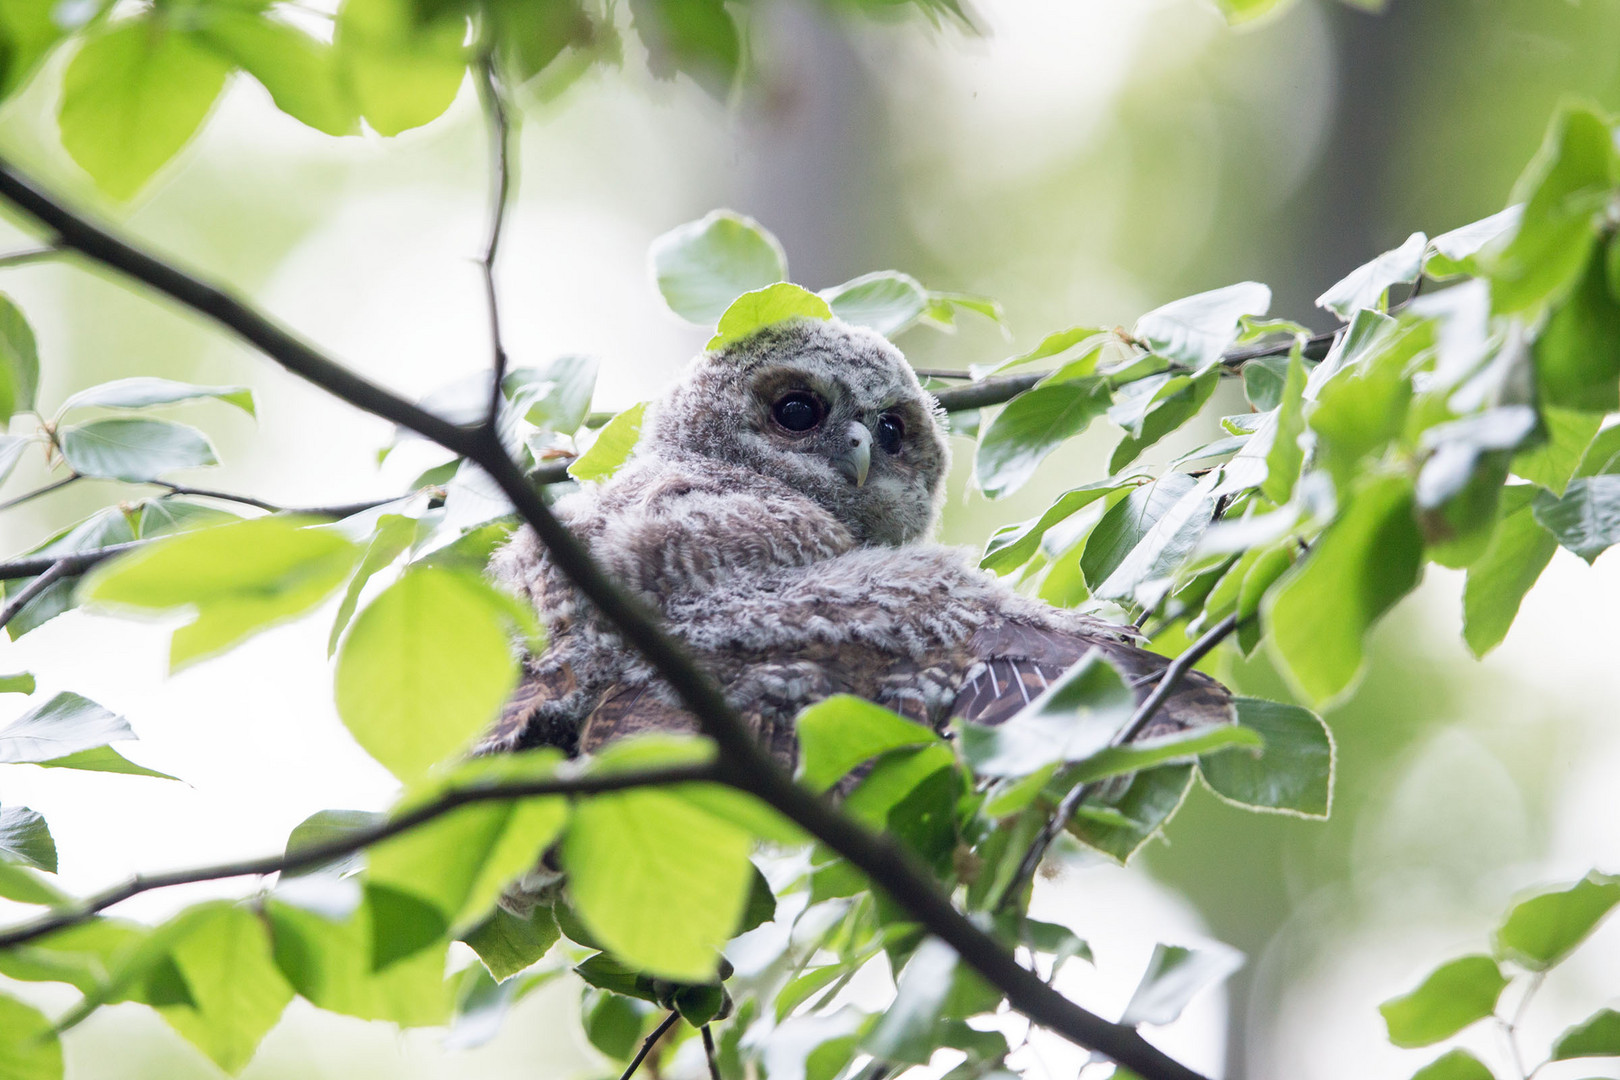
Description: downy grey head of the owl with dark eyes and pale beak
xmin=638 ymin=319 xmax=949 ymax=544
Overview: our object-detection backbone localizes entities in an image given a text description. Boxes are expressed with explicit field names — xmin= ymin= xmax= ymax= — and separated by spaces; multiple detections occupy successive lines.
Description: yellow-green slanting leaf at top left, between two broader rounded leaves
xmin=198 ymin=5 xmax=360 ymax=134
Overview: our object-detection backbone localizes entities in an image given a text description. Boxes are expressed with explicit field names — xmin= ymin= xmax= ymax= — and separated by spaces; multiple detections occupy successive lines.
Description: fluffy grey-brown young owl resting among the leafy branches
xmin=481 ymin=319 xmax=1231 ymax=767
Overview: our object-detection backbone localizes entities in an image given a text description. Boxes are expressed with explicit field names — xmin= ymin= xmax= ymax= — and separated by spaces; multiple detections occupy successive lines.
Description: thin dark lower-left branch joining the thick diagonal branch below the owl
xmin=0 ymin=764 xmax=721 ymax=949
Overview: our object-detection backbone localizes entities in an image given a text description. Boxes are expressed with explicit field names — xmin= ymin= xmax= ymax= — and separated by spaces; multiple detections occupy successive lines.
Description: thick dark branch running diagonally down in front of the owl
xmin=0 ymin=159 xmax=1202 ymax=1080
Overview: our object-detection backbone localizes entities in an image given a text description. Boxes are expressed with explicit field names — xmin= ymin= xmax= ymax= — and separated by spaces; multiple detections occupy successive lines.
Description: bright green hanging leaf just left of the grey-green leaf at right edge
xmin=1463 ymin=484 xmax=1558 ymax=656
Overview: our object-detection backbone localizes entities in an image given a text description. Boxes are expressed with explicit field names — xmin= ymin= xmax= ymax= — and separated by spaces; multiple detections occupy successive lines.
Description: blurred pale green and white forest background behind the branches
xmin=0 ymin=0 xmax=1620 ymax=1080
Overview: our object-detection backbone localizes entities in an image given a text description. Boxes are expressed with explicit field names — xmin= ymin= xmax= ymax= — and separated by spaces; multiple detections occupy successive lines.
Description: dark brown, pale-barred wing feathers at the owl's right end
xmin=951 ymin=619 xmax=1234 ymax=735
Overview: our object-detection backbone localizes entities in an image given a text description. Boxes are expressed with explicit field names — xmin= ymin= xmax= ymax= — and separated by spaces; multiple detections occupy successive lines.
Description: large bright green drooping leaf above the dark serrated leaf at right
xmin=1262 ymin=476 xmax=1422 ymax=703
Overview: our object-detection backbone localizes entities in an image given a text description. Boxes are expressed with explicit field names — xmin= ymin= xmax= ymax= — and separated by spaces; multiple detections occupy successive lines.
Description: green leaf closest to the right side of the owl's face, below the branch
xmin=974 ymin=379 xmax=1108 ymax=499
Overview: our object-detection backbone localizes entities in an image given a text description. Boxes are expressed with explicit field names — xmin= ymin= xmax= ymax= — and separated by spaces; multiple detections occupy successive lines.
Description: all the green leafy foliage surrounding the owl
xmin=0 ymin=0 xmax=1620 ymax=1080
